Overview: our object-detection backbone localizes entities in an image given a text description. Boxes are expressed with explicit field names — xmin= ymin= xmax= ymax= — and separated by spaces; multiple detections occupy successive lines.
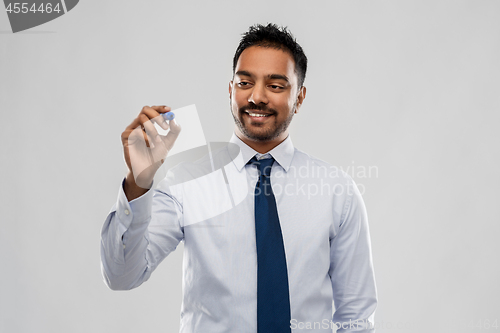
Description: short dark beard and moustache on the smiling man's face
xmin=229 ymin=101 xmax=297 ymax=142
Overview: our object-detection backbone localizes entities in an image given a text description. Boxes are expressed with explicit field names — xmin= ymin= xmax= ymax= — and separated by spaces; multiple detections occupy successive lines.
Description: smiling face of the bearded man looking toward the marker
xmin=229 ymin=46 xmax=305 ymax=143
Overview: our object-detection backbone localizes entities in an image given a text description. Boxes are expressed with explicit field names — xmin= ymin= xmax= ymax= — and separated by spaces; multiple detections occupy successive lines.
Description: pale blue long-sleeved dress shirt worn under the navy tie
xmin=101 ymin=134 xmax=377 ymax=333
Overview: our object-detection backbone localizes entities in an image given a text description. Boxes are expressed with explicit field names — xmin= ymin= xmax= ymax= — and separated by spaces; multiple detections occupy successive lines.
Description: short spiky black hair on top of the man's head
xmin=233 ymin=23 xmax=307 ymax=88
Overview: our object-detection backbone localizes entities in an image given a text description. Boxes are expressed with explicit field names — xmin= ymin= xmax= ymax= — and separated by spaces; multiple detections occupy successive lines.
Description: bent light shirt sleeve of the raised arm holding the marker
xmin=101 ymin=178 xmax=183 ymax=290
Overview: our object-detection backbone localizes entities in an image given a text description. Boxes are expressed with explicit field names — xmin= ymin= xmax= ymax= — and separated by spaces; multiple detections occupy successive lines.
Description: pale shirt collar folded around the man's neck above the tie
xmin=229 ymin=133 xmax=295 ymax=172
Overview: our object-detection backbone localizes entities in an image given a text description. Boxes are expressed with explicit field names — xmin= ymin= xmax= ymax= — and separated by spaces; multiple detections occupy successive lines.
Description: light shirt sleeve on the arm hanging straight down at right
xmin=330 ymin=180 xmax=377 ymax=333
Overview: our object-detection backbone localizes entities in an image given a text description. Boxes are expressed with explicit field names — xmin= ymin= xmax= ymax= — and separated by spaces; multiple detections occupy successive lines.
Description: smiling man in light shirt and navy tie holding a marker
xmin=101 ymin=24 xmax=377 ymax=333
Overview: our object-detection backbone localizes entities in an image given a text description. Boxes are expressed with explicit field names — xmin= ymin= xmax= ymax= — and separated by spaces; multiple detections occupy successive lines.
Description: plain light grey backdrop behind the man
xmin=0 ymin=0 xmax=500 ymax=333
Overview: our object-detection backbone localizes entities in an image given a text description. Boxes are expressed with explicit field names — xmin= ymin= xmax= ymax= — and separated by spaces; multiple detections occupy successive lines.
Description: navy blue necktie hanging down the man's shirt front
xmin=250 ymin=157 xmax=291 ymax=333
